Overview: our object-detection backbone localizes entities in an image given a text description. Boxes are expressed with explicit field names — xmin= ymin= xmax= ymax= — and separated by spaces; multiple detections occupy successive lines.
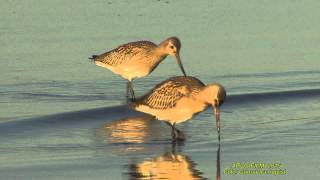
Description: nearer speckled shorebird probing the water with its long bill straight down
xmin=130 ymin=76 xmax=226 ymax=142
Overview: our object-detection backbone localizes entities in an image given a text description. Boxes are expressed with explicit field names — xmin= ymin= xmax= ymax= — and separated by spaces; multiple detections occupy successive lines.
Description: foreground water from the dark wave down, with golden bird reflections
xmin=0 ymin=90 xmax=320 ymax=179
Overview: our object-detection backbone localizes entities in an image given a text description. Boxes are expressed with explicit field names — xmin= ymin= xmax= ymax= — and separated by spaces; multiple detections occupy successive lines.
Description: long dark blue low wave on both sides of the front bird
xmin=0 ymin=89 xmax=320 ymax=140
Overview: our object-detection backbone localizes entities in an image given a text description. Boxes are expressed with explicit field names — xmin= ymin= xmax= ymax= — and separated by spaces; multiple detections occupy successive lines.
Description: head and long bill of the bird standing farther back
xmin=160 ymin=37 xmax=187 ymax=76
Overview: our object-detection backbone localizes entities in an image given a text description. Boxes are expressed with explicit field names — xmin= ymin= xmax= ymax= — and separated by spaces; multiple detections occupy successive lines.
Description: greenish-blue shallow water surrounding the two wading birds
xmin=0 ymin=0 xmax=320 ymax=180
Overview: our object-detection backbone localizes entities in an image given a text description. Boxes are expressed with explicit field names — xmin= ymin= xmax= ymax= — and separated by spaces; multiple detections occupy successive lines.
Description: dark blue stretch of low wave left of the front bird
xmin=0 ymin=105 xmax=141 ymax=137
